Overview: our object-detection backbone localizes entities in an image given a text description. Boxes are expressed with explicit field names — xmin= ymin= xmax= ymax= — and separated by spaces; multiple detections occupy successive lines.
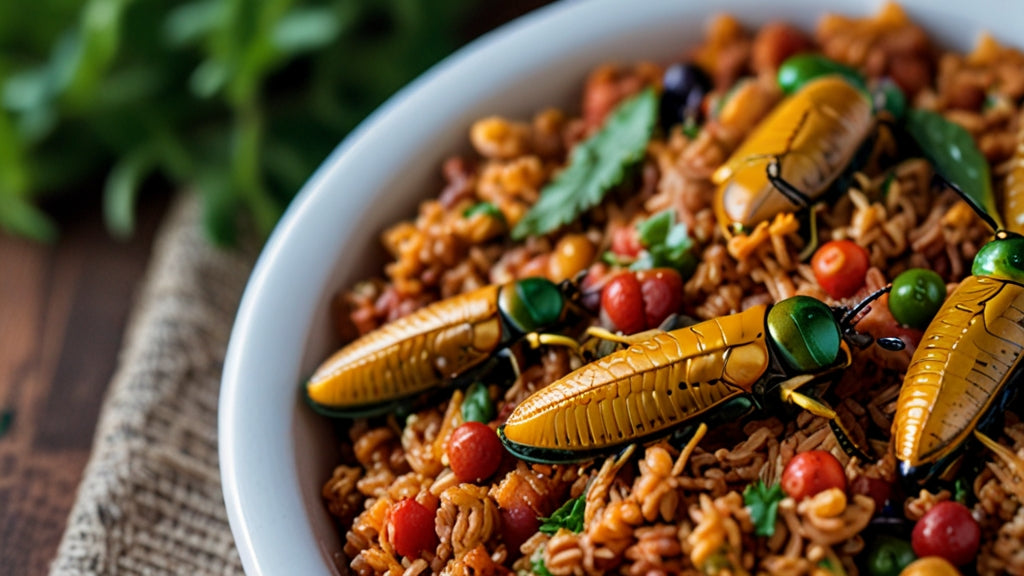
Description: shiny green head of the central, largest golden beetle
xmin=768 ymin=296 xmax=842 ymax=372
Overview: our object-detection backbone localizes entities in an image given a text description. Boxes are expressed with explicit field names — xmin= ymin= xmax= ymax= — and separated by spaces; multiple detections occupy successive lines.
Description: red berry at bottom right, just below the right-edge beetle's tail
xmin=910 ymin=500 xmax=981 ymax=566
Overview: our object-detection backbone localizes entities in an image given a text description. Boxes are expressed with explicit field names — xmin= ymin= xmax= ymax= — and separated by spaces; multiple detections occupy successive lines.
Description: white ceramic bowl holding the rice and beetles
xmin=219 ymin=0 xmax=1024 ymax=575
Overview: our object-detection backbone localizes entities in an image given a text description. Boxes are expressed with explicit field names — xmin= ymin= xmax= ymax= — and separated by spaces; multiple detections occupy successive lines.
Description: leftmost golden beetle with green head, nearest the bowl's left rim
xmin=305 ymin=278 xmax=574 ymax=418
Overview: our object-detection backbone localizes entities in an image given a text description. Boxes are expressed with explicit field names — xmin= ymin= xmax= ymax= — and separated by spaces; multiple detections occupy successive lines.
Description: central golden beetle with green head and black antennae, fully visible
xmin=498 ymin=290 xmax=900 ymax=462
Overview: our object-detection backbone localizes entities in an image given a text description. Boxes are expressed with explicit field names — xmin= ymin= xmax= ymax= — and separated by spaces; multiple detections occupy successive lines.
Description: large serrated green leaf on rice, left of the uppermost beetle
xmin=512 ymin=88 xmax=657 ymax=240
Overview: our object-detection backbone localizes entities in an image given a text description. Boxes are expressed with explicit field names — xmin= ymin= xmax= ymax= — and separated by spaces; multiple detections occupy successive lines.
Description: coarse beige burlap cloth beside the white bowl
xmin=51 ymin=194 xmax=258 ymax=575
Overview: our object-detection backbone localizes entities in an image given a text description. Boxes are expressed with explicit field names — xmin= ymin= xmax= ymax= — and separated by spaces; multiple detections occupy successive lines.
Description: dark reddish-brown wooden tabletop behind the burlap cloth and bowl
xmin=0 ymin=0 xmax=550 ymax=575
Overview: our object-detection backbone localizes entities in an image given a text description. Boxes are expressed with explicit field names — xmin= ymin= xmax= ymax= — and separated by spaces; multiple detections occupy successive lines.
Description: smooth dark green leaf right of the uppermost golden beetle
xmin=906 ymin=109 xmax=1002 ymax=230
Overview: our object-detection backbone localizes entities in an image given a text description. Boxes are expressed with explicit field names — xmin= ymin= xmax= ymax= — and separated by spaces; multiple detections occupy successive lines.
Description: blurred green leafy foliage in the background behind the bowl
xmin=0 ymin=0 xmax=471 ymax=239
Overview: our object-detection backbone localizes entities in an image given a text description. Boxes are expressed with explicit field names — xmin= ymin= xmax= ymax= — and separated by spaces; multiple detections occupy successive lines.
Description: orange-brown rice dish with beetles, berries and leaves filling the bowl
xmin=303 ymin=4 xmax=1024 ymax=576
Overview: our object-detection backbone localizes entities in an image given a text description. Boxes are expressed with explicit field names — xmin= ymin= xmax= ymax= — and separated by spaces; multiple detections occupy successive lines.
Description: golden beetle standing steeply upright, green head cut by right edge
xmin=893 ymin=232 xmax=1024 ymax=482
